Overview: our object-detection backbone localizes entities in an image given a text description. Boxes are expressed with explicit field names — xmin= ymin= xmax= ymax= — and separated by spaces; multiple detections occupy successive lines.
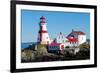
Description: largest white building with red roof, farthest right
xmin=67 ymin=30 xmax=86 ymax=46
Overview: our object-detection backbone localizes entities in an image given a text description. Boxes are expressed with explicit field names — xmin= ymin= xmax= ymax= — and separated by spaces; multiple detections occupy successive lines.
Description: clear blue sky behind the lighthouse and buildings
xmin=21 ymin=10 xmax=90 ymax=43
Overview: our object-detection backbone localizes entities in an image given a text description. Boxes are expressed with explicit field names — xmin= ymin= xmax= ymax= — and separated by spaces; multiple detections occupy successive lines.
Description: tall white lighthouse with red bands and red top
xmin=38 ymin=16 xmax=50 ymax=44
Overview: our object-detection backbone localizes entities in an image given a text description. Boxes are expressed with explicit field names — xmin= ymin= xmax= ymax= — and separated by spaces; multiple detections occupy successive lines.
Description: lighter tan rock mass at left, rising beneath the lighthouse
xmin=21 ymin=44 xmax=49 ymax=62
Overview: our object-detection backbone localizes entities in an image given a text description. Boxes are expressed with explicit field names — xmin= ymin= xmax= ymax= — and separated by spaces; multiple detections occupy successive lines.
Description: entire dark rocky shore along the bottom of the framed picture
xmin=21 ymin=44 xmax=90 ymax=63
